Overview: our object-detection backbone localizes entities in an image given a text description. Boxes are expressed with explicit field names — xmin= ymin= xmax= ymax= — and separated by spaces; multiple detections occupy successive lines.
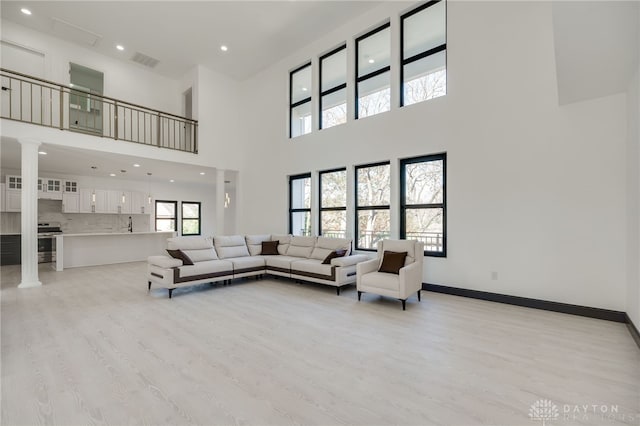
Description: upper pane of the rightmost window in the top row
xmin=403 ymin=1 xmax=447 ymax=59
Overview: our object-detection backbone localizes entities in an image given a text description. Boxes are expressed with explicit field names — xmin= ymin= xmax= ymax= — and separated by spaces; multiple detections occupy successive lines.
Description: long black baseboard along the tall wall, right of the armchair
xmin=422 ymin=283 xmax=637 ymax=322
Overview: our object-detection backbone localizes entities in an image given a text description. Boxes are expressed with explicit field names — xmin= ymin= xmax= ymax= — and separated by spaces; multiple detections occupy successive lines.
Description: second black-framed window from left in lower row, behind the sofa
xmin=319 ymin=169 xmax=347 ymax=238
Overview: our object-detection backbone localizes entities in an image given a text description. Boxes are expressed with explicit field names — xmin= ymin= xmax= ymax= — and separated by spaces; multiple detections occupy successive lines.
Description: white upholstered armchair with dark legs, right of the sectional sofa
xmin=356 ymin=240 xmax=424 ymax=310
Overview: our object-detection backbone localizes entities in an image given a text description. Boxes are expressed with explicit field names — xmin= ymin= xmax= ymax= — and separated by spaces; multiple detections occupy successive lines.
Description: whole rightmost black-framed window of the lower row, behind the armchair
xmin=400 ymin=154 xmax=447 ymax=257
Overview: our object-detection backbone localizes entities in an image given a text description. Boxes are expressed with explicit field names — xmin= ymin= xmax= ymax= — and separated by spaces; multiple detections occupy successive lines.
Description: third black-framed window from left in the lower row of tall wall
xmin=356 ymin=162 xmax=391 ymax=250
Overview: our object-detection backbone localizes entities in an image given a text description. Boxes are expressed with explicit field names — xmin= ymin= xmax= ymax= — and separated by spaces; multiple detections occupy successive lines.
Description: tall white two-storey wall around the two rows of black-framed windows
xmin=238 ymin=2 xmax=626 ymax=310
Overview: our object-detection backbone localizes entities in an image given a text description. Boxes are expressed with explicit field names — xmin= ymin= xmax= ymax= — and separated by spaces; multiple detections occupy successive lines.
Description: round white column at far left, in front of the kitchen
xmin=18 ymin=139 xmax=42 ymax=288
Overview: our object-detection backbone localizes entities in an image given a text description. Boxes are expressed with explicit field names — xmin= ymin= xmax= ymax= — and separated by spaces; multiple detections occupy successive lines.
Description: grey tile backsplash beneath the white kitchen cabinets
xmin=0 ymin=200 xmax=151 ymax=234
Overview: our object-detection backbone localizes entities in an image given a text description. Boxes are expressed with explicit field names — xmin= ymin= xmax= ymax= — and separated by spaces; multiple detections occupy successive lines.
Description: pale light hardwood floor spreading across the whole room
xmin=0 ymin=263 xmax=640 ymax=426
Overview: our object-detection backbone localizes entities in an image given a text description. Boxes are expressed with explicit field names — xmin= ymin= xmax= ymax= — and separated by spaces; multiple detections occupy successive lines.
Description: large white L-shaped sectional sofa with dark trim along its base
xmin=147 ymin=234 xmax=369 ymax=298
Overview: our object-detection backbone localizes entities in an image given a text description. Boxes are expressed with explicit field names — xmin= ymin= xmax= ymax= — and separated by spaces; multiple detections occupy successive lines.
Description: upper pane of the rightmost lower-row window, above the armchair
xmin=404 ymin=160 xmax=444 ymax=205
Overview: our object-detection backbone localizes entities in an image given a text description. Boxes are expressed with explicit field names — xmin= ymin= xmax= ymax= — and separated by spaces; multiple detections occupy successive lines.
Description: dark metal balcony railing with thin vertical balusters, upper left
xmin=0 ymin=68 xmax=198 ymax=154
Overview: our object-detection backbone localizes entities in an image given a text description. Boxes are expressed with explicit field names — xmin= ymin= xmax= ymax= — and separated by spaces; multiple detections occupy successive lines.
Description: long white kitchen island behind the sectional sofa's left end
xmin=56 ymin=231 xmax=176 ymax=271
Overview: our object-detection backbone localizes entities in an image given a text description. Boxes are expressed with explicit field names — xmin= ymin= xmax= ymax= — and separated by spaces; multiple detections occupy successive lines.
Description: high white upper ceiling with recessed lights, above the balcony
xmin=0 ymin=0 xmax=380 ymax=80
